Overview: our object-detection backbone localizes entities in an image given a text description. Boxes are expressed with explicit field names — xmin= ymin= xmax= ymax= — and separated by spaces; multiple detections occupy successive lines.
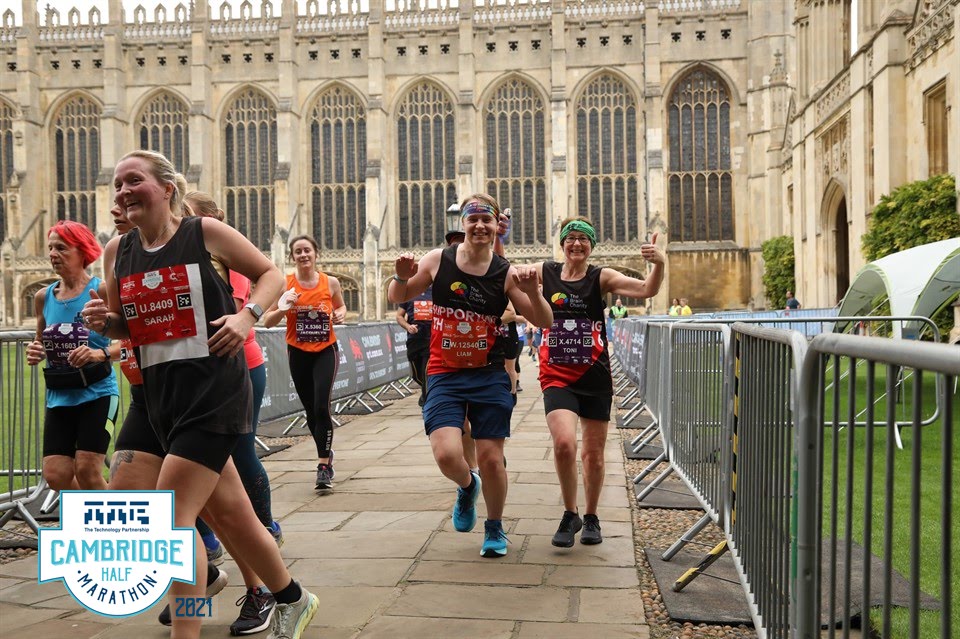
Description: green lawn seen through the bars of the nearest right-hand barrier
xmin=823 ymin=362 xmax=960 ymax=637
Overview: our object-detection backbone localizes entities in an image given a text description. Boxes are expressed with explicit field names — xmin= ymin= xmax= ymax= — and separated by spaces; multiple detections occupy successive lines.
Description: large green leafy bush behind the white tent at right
xmin=862 ymin=174 xmax=960 ymax=262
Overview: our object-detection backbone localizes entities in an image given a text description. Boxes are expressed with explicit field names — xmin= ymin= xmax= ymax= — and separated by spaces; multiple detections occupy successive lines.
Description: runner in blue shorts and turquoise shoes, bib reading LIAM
xmin=388 ymin=194 xmax=552 ymax=557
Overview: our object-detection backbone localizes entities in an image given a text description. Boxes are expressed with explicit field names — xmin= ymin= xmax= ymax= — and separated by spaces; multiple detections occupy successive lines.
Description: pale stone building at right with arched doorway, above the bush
xmin=782 ymin=0 xmax=960 ymax=307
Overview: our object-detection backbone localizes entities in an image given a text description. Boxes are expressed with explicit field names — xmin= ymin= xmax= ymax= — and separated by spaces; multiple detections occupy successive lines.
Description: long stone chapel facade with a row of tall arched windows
xmin=0 ymin=0 xmax=792 ymax=326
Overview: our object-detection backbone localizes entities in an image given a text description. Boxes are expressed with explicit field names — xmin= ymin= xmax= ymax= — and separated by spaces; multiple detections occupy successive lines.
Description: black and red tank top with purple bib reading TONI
xmin=540 ymin=261 xmax=613 ymax=395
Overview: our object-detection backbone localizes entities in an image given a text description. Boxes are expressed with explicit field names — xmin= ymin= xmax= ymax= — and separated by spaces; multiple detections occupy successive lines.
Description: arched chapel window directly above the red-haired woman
xmin=53 ymin=96 xmax=100 ymax=230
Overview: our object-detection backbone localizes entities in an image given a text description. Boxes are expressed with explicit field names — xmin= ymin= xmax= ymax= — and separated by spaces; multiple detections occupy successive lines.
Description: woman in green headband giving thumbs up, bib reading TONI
xmin=536 ymin=217 xmax=664 ymax=548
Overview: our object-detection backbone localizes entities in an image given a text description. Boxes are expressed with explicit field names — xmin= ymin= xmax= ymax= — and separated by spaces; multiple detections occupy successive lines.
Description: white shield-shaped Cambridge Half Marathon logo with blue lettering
xmin=38 ymin=490 xmax=195 ymax=617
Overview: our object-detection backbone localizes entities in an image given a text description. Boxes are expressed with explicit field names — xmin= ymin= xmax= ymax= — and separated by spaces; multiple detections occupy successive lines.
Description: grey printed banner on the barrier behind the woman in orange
xmin=256 ymin=323 xmax=410 ymax=421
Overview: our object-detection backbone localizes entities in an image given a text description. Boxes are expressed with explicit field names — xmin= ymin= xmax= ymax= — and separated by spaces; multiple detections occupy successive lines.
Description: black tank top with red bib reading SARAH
xmin=114 ymin=217 xmax=252 ymax=447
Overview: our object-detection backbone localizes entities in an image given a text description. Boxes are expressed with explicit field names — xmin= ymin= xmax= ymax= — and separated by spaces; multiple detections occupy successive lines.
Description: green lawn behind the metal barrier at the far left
xmin=0 ymin=342 xmax=130 ymax=494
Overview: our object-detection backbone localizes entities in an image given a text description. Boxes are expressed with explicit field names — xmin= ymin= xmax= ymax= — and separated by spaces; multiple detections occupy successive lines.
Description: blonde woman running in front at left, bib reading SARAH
xmin=83 ymin=151 xmax=319 ymax=638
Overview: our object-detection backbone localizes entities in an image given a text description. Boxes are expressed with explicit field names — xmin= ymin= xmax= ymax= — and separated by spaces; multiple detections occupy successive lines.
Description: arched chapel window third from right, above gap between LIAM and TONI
xmin=483 ymin=78 xmax=549 ymax=244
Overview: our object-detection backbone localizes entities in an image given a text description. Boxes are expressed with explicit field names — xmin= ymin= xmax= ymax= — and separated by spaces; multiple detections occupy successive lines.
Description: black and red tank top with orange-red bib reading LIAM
xmin=427 ymin=245 xmax=510 ymax=375
